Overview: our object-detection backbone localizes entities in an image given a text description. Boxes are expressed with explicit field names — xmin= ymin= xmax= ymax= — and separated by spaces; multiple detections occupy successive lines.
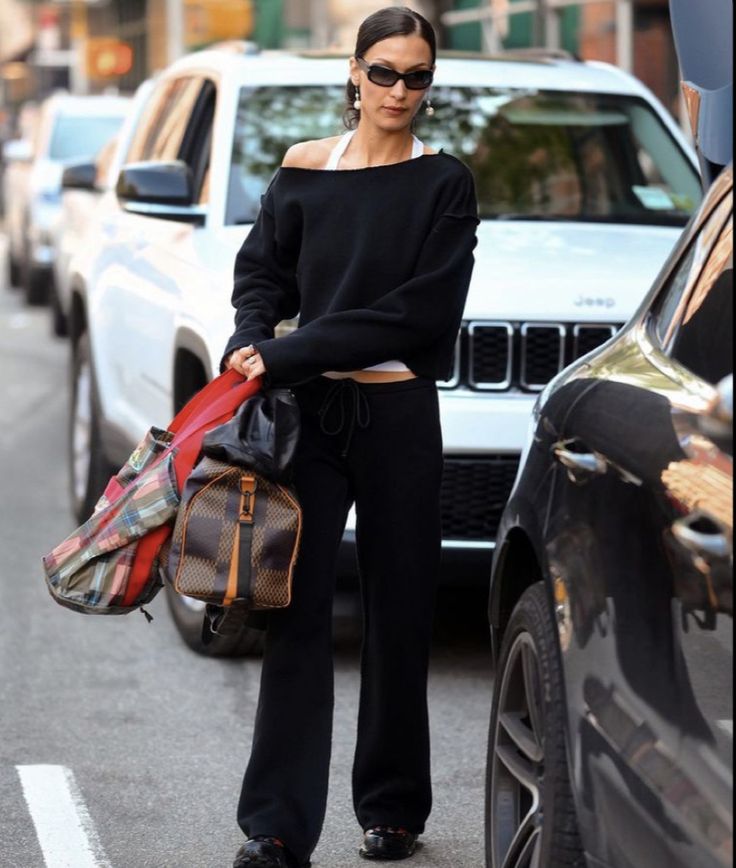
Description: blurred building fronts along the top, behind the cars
xmin=0 ymin=0 xmax=679 ymax=122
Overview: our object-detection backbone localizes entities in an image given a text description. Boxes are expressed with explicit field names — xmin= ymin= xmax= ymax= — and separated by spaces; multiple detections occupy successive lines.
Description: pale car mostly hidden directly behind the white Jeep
xmin=49 ymin=78 xmax=154 ymax=337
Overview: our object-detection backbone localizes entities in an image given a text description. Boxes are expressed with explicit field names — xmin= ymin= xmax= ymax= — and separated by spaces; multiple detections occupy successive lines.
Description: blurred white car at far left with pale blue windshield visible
xmin=3 ymin=93 xmax=129 ymax=304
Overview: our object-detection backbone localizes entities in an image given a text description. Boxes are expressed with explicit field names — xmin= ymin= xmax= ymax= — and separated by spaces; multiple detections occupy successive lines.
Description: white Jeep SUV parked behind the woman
xmin=70 ymin=40 xmax=702 ymax=647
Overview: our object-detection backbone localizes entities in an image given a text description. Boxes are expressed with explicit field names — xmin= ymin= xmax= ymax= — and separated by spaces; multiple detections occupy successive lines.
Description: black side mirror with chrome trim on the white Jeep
xmin=115 ymin=160 xmax=206 ymax=223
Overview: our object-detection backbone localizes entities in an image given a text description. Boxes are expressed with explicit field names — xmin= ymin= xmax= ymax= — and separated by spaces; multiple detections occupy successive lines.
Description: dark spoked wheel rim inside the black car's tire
xmin=489 ymin=632 xmax=544 ymax=868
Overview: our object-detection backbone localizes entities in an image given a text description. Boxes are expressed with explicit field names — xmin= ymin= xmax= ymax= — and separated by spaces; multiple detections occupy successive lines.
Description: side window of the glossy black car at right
xmin=649 ymin=195 xmax=733 ymax=384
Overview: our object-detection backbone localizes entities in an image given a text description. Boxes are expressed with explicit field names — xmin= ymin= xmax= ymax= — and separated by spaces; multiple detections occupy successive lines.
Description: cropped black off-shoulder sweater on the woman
xmin=225 ymin=153 xmax=478 ymax=385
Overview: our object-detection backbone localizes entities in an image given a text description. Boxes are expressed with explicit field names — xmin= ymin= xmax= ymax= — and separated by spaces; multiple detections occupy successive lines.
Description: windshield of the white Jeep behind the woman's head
xmin=227 ymin=85 xmax=702 ymax=226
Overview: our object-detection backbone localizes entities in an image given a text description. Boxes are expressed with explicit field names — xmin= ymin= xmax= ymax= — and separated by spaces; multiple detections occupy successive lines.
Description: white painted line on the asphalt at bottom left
xmin=16 ymin=765 xmax=111 ymax=868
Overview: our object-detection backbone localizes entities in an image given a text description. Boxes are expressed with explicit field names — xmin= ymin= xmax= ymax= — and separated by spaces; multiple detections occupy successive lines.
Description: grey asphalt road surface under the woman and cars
xmin=0 ymin=236 xmax=490 ymax=868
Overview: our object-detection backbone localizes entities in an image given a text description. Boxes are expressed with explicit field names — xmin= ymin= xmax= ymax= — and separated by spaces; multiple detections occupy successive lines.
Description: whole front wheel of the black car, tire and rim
xmin=485 ymin=582 xmax=586 ymax=868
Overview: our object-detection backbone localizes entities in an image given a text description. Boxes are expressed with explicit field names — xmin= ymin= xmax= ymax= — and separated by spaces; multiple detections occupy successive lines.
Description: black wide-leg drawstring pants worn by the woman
xmin=238 ymin=378 xmax=442 ymax=861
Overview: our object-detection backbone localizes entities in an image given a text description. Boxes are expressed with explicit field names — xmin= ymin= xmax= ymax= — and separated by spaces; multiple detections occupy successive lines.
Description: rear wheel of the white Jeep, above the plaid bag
xmin=68 ymin=332 xmax=115 ymax=524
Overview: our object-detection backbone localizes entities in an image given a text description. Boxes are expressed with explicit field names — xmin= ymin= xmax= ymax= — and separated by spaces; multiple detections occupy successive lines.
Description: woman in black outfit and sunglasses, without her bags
xmin=224 ymin=7 xmax=478 ymax=868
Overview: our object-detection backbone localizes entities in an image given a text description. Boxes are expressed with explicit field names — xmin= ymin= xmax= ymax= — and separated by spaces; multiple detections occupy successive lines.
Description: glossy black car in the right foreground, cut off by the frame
xmin=486 ymin=167 xmax=733 ymax=868
